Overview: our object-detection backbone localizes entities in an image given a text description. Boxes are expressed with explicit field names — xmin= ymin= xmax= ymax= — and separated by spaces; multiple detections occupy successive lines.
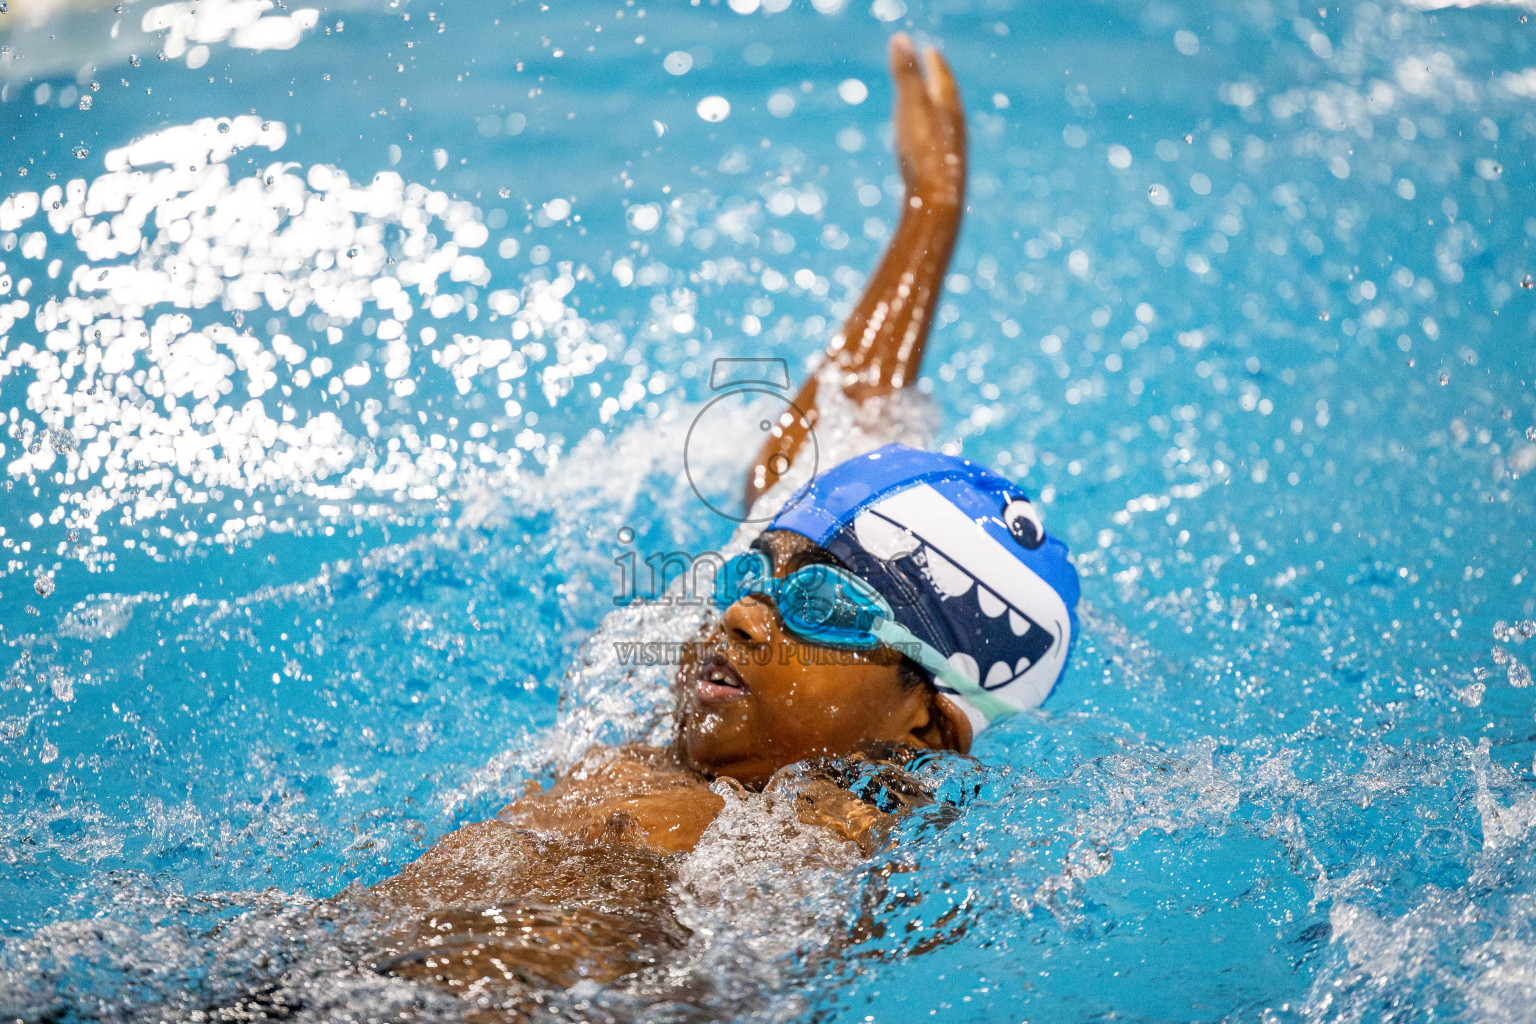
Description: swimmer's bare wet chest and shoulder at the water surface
xmin=366 ymin=746 xmax=892 ymax=994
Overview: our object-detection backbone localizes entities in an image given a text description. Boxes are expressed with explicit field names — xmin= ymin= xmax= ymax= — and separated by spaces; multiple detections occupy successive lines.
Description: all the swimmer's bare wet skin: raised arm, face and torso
xmin=359 ymin=35 xmax=971 ymax=1019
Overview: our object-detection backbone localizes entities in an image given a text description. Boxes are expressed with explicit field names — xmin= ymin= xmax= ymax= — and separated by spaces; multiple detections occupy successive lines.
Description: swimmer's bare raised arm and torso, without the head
xmin=359 ymin=35 xmax=966 ymax=1007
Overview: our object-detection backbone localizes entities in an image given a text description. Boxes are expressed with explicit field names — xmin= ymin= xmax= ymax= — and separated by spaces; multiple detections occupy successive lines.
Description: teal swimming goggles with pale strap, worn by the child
xmin=714 ymin=550 xmax=1014 ymax=722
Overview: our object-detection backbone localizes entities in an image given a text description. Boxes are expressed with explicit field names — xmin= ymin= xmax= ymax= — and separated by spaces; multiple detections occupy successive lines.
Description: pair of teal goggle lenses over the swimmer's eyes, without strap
xmin=714 ymin=551 xmax=891 ymax=651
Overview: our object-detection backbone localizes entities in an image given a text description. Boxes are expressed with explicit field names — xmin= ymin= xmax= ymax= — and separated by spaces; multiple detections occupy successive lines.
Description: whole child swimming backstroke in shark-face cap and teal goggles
xmin=359 ymin=35 xmax=1078 ymax=1009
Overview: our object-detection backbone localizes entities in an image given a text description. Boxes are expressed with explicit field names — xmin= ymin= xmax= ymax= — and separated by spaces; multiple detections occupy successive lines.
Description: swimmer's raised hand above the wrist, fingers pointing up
xmin=891 ymin=32 xmax=965 ymax=209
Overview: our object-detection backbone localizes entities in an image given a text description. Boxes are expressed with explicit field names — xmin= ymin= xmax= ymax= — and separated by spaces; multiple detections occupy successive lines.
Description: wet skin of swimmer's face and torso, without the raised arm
xmin=359 ymin=531 xmax=969 ymax=990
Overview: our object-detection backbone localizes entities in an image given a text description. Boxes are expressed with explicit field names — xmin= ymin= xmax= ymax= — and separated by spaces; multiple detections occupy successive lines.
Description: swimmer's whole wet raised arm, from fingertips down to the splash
xmin=746 ymin=34 xmax=965 ymax=507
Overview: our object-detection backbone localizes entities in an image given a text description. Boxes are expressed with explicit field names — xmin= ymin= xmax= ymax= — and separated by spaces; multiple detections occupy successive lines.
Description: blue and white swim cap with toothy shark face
xmin=768 ymin=444 xmax=1078 ymax=732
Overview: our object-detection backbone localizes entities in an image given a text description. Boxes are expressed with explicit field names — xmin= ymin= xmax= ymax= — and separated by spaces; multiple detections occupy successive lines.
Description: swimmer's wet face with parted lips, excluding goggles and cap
xmin=677 ymin=531 xmax=969 ymax=786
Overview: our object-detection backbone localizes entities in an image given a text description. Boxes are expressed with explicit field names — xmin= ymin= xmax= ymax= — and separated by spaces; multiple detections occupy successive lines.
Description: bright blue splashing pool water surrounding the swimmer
xmin=0 ymin=0 xmax=1536 ymax=1024
